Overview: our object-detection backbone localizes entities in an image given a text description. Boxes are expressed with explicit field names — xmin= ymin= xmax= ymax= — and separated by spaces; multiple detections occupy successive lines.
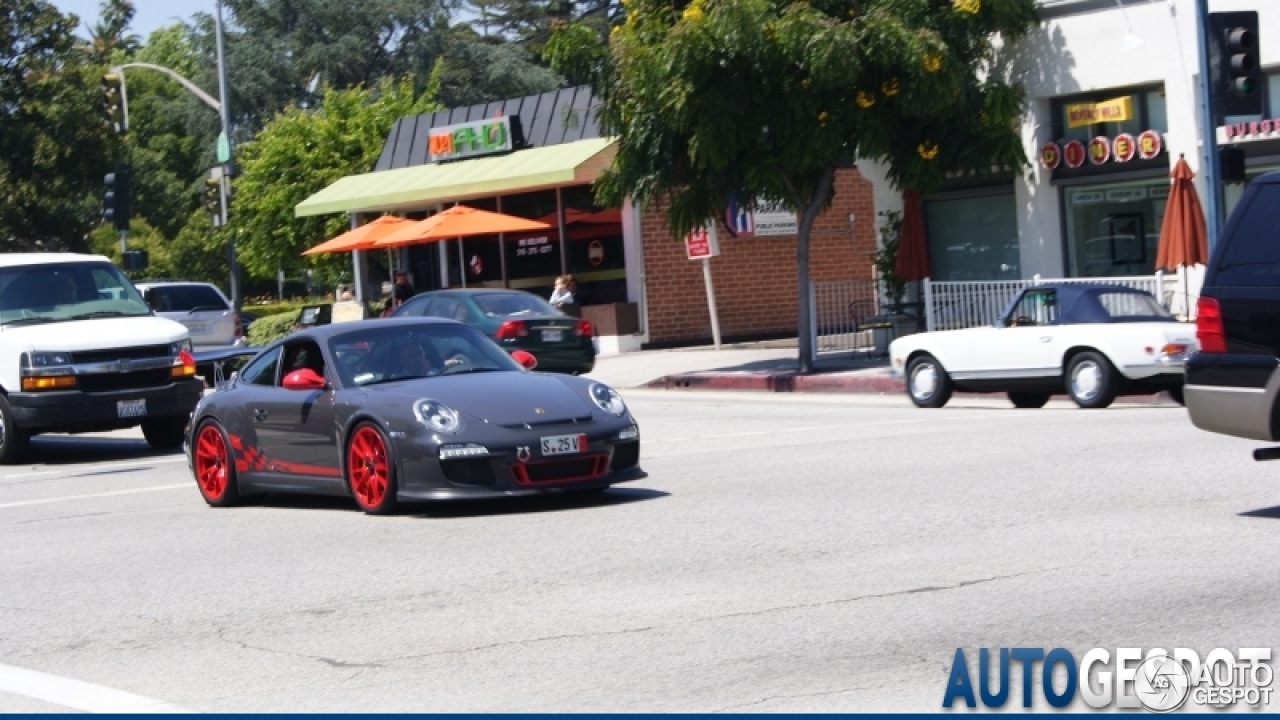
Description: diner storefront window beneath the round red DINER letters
xmin=1065 ymin=178 xmax=1169 ymax=278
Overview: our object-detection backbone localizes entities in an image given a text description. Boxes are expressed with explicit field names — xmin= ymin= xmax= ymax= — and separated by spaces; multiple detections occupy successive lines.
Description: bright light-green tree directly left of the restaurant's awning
xmin=229 ymin=74 xmax=436 ymax=283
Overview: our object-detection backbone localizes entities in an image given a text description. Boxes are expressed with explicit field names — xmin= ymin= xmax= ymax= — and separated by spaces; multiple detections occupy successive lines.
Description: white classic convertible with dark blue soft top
xmin=888 ymin=284 xmax=1196 ymax=407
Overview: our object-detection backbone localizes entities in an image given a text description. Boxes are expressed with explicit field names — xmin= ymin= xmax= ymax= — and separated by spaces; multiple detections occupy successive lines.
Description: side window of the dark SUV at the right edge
xmin=1215 ymin=184 xmax=1280 ymax=287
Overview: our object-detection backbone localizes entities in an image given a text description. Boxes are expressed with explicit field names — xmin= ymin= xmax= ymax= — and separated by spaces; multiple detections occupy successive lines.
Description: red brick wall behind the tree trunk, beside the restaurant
xmin=640 ymin=169 xmax=876 ymax=343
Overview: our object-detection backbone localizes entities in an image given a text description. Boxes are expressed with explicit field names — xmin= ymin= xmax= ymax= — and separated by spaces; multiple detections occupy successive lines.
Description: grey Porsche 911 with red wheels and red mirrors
xmin=187 ymin=318 xmax=644 ymax=514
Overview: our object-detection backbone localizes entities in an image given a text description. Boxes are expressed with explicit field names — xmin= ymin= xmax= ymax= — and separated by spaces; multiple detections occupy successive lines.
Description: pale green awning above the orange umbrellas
xmin=293 ymin=138 xmax=614 ymax=218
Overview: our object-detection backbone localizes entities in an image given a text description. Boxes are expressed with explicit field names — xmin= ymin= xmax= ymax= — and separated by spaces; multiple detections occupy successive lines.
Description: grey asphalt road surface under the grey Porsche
xmin=0 ymin=391 xmax=1280 ymax=712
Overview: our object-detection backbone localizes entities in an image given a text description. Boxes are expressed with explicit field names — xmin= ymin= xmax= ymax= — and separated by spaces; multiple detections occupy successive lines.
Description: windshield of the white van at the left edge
xmin=0 ymin=261 xmax=151 ymax=325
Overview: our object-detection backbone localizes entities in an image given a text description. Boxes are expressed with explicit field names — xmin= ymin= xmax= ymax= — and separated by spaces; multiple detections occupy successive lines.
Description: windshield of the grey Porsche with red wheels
xmin=329 ymin=323 xmax=521 ymax=387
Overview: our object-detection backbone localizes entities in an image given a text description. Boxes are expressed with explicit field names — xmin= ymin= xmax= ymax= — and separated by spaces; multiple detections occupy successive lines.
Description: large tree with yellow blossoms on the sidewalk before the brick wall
xmin=547 ymin=0 xmax=1036 ymax=372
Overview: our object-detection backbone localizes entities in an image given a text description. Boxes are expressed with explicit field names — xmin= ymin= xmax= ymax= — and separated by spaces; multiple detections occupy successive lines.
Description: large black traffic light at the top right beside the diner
xmin=1208 ymin=10 xmax=1262 ymax=120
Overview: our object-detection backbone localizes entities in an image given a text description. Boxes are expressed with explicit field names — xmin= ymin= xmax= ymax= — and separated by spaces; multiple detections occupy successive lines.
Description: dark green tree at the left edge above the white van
xmin=0 ymin=0 xmax=118 ymax=251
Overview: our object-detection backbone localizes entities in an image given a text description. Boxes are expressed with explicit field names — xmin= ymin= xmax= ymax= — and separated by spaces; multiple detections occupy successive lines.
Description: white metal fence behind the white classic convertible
xmin=922 ymin=273 xmax=1196 ymax=331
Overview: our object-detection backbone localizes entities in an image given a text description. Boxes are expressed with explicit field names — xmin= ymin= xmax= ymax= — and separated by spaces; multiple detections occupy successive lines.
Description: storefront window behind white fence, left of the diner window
xmin=924 ymin=192 xmax=1021 ymax=281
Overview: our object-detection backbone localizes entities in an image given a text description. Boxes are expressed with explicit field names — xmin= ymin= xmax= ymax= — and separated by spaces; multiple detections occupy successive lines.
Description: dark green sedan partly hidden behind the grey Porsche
xmin=392 ymin=288 xmax=595 ymax=374
